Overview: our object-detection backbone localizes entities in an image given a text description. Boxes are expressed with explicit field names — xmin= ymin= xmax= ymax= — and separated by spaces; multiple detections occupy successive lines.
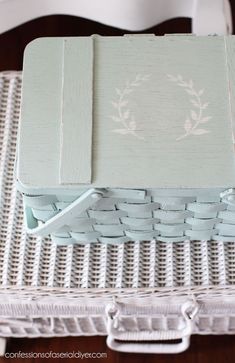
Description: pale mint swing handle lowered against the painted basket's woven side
xmin=25 ymin=189 xmax=106 ymax=237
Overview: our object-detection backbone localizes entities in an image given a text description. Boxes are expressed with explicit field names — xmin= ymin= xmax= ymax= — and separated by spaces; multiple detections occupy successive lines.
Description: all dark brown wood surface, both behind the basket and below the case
xmin=0 ymin=4 xmax=235 ymax=363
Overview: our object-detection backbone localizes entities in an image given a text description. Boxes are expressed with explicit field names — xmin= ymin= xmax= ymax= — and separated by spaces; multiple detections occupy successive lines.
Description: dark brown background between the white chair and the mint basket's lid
xmin=0 ymin=15 xmax=191 ymax=71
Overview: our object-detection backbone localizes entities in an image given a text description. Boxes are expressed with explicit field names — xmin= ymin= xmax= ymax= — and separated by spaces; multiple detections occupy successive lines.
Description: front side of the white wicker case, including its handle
xmin=0 ymin=288 xmax=235 ymax=353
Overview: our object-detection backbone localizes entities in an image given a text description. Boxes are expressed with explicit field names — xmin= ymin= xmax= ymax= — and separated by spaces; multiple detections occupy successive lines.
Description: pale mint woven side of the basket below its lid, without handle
xmin=24 ymin=190 xmax=235 ymax=245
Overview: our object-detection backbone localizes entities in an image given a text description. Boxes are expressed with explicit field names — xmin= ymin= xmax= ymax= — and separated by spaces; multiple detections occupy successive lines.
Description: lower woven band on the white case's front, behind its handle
xmin=0 ymin=314 xmax=235 ymax=338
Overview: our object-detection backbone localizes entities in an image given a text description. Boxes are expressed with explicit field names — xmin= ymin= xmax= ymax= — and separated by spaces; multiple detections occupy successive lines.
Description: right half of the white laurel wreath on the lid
xmin=167 ymin=74 xmax=212 ymax=140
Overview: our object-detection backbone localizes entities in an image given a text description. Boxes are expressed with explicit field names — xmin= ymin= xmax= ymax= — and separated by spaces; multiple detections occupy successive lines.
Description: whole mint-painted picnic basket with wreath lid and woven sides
xmin=16 ymin=35 xmax=235 ymax=245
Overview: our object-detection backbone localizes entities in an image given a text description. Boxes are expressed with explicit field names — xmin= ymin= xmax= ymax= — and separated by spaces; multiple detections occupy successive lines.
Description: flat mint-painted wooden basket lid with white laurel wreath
xmin=17 ymin=35 xmax=235 ymax=192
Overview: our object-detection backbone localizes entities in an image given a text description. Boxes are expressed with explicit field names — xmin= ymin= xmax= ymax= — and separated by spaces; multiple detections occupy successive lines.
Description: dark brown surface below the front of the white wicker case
xmin=0 ymin=335 xmax=235 ymax=363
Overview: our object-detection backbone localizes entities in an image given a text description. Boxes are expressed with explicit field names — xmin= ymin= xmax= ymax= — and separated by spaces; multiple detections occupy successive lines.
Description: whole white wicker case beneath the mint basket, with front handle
xmin=0 ymin=72 xmax=235 ymax=352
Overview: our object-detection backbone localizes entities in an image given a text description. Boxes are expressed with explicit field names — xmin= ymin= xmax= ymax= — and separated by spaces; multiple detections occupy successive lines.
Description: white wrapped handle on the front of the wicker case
xmin=106 ymin=300 xmax=198 ymax=353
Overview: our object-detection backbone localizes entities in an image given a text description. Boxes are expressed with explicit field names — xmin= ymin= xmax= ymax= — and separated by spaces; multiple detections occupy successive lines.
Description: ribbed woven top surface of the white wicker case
xmin=0 ymin=72 xmax=235 ymax=289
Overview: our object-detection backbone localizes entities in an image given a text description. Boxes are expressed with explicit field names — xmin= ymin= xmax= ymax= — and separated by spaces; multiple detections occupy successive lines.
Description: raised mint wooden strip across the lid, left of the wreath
xmin=59 ymin=37 xmax=93 ymax=184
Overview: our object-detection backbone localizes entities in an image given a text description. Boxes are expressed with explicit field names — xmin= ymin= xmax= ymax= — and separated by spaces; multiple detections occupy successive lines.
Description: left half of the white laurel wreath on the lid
xmin=110 ymin=74 xmax=150 ymax=140
